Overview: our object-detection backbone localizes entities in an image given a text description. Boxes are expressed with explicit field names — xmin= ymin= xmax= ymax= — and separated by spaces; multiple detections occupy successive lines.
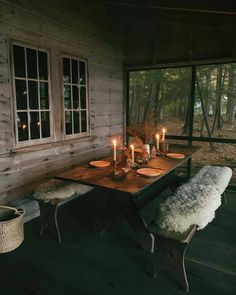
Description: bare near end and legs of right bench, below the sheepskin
xmin=149 ymin=225 xmax=197 ymax=292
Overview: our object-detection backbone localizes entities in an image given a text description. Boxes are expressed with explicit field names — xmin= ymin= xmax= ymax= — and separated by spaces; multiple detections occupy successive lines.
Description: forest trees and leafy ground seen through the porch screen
xmin=128 ymin=63 xmax=236 ymax=184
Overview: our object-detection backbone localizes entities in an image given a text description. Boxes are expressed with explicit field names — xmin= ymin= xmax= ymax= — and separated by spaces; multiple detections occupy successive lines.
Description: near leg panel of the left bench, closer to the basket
xmin=39 ymin=201 xmax=61 ymax=243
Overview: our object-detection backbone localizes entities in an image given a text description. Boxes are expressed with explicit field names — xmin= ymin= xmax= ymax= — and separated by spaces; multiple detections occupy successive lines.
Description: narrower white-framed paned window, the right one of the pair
xmin=62 ymin=55 xmax=89 ymax=138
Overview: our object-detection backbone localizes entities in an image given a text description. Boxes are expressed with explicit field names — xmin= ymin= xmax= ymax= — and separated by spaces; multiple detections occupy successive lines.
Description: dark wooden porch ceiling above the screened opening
xmin=106 ymin=0 xmax=236 ymax=68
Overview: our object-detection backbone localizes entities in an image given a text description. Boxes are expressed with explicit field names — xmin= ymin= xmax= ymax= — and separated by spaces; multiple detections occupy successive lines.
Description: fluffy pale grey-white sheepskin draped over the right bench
xmin=153 ymin=166 xmax=232 ymax=233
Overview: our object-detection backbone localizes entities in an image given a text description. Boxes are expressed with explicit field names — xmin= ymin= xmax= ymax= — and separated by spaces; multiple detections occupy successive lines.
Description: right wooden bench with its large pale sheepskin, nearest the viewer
xmin=149 ymin=166 xmax=232 ymax=292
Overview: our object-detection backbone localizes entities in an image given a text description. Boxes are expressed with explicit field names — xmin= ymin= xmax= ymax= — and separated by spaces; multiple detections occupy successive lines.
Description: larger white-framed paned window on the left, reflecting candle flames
xmin=11 ymin=42 xmax=52 ymax=147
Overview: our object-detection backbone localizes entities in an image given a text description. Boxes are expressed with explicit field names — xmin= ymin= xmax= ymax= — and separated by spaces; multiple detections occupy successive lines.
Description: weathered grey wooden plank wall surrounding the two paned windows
xmin=0 ymin=0 xmax=124 ymax=204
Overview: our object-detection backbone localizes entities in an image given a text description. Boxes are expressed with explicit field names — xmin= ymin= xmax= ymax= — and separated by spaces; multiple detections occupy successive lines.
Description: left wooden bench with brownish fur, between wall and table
xmin=30 ymin=179 xmax=93 ymax=243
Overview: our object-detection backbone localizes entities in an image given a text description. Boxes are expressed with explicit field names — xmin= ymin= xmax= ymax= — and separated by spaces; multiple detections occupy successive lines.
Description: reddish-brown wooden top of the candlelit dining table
xmin=55 ymin=145 xmax=199 ymax=195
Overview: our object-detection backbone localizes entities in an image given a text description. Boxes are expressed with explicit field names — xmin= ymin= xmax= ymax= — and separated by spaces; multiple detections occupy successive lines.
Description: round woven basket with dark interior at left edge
xmin=0 ymin=206 xmax=24 ymax=253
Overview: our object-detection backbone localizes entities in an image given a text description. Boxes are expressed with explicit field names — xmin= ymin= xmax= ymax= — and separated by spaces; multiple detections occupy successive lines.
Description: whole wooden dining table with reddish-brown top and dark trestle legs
xmin=55 ymin=145 xmax=199 ymax=251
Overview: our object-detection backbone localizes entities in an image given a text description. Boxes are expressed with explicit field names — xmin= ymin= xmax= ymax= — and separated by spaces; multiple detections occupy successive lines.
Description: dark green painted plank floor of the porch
xmin=0 ymin=192 xmax=236 ymax=295
